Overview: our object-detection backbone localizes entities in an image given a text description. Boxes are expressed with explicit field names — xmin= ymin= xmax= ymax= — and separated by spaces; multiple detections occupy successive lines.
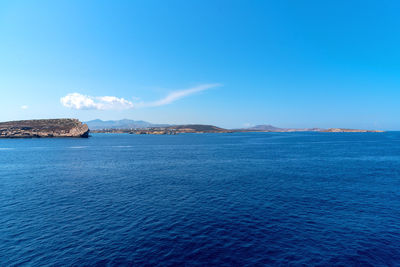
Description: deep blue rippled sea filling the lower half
xmin=0 ymin=132 xmax=400 ymax=266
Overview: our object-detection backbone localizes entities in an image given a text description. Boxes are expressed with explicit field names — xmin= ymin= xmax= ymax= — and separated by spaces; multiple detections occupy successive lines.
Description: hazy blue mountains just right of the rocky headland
xmin=85 ymin=119 xmax=169 ymax=130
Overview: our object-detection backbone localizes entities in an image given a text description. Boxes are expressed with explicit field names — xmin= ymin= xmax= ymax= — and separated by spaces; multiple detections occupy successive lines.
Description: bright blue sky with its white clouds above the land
xmin=0 ymin=0 xmax=400 ymax=130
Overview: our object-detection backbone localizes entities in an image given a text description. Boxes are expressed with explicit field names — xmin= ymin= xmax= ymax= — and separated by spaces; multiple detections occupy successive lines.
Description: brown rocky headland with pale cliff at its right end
xmin=0 ymin=119 xmax=89 ymax=138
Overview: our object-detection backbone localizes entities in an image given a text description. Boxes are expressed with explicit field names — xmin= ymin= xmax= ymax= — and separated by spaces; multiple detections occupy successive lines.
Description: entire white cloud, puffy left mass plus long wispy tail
xmin=60 ymin=83 xmax=221 ymax=110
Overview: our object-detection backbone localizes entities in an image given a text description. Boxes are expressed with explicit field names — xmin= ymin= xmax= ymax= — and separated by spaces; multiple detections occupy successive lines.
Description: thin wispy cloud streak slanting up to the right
xmin=135 ymin=83 xmax=222 ymax=108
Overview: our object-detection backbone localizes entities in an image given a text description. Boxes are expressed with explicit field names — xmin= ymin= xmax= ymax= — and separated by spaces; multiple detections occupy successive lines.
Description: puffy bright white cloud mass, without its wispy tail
xmin=60 ymin=93 xmax=133 ymax=110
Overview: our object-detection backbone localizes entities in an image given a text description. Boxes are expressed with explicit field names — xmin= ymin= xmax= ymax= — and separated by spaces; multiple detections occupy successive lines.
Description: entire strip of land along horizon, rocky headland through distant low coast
xmin=0 ymin=119 xmax=382 ymax=138
